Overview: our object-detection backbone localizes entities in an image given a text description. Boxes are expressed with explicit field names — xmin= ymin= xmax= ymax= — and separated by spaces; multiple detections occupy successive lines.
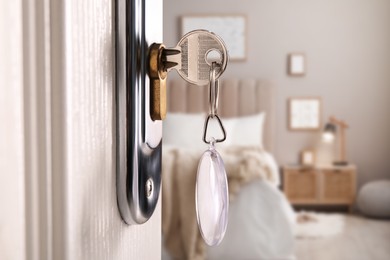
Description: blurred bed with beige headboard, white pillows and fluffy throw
xmin=162 ymin=79 xmax=294 ymax=259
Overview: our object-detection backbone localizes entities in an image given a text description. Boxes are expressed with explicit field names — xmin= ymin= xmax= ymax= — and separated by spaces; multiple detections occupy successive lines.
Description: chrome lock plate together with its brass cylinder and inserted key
xmin=115 ymin=0 xmax=228 ymax=224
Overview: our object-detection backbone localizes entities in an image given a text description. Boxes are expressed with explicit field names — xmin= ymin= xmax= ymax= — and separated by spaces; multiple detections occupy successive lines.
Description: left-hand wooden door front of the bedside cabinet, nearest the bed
xmin=284 ymin=169 xmax=317 ymax=203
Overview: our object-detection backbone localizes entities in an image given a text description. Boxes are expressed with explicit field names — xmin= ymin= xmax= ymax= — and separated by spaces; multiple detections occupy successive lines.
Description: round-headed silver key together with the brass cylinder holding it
xmin=148 ymin=30 xmax=229 ymax=120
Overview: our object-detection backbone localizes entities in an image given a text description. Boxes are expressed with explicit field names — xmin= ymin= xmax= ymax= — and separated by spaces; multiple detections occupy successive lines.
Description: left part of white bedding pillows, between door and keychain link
xmin=163 ymin=113 xmax=207 ymax=149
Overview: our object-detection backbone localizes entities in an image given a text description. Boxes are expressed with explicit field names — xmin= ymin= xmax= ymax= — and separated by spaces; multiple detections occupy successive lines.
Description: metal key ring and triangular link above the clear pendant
xmin=203 ymin=62 xmax=226 ymax=144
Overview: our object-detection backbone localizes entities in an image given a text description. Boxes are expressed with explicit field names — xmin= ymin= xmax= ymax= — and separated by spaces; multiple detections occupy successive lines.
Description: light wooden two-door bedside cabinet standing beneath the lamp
xmin=283 ymin=164 xmax=356 ymax=210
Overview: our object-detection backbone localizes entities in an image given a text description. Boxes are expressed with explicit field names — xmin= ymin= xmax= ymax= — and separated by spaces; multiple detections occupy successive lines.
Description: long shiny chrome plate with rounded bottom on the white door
xmin=115 ymin=0 xmax=162 ymax=224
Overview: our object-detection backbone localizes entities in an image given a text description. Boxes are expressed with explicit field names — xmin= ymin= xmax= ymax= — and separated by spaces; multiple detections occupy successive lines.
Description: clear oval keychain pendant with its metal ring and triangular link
xmin=195 ymin=62 xmax=229 ymax=246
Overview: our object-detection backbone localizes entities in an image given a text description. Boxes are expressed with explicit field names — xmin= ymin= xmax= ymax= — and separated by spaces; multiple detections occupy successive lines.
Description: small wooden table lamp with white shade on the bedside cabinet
xmin=322 ymin=116 xmax=349 ymax=166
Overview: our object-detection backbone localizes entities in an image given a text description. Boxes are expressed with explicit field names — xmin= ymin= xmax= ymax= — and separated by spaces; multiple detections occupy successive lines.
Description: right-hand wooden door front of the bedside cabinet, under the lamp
xmin=321 ymin=169 xmax=355 ymax=203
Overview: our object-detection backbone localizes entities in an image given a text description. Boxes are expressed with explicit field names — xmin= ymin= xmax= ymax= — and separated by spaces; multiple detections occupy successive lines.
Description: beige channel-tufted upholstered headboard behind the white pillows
xmin=167 ymin=79 xmax=275 ymax=153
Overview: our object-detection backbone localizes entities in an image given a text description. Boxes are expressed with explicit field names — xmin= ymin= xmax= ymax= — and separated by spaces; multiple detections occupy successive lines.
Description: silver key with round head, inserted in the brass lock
xmin=163 ymin=30 xmax=228 ymax=86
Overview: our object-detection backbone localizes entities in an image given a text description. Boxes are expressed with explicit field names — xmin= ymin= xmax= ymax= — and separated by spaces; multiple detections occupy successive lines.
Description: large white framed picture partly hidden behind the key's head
xmin=181 ymin=15 xmax=246 ymax=61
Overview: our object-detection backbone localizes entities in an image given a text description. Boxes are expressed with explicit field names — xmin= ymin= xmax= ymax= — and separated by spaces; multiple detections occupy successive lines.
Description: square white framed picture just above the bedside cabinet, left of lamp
xmin=288 ymin=98 xmax=321 ymax=130
